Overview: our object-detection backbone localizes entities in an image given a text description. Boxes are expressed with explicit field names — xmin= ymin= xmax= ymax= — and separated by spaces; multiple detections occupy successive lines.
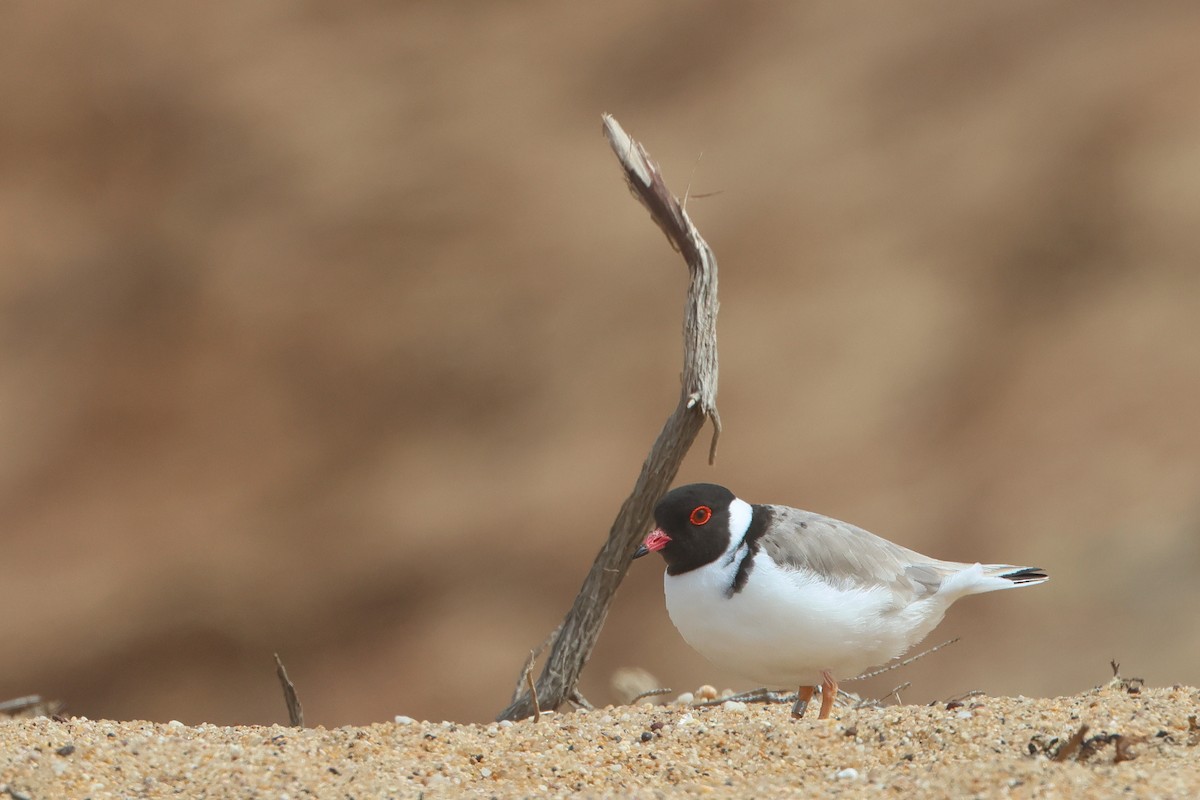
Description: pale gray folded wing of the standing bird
xmin=758 ymin=506 xmax=968 ymax=604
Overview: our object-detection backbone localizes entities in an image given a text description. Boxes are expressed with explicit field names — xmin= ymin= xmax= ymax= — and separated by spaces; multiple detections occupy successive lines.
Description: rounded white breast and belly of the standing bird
xmin=664 ymin=553 xmax=948 ymax=687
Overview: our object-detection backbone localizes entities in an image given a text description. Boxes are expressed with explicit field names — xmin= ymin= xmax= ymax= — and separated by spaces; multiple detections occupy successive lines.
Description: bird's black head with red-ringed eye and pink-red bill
xmin=634 ymin=483 xmax=737 ymax=575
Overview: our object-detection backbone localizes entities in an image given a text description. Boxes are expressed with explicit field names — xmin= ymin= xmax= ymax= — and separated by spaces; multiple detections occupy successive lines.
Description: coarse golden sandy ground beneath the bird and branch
xmin=0 ymin=681 xmax=1200 ymax=800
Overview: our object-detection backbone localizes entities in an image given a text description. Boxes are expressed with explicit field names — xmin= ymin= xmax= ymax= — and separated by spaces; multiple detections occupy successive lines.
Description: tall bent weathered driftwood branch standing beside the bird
xmin=497 ymin=114 xmax=721 ymax=720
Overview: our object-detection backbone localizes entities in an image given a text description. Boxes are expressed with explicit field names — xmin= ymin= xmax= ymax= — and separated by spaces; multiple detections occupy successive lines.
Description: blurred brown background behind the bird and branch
xmin=0 ymin=0 xmax=1200 ymax=726
